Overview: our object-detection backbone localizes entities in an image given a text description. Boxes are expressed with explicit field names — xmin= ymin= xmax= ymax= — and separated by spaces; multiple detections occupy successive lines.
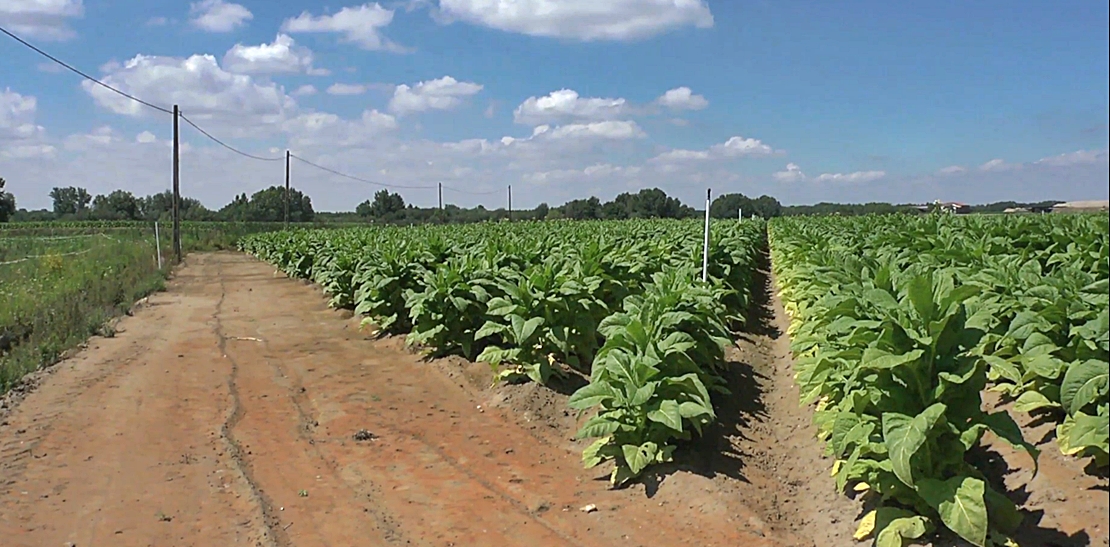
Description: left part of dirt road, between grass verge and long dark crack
xmin=0 ymin=261 xmax=268 ymax=547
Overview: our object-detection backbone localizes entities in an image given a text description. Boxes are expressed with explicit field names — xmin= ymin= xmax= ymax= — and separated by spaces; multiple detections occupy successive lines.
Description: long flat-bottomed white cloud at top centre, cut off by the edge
xmin=440 ymin=0 xmax=713 ymax=41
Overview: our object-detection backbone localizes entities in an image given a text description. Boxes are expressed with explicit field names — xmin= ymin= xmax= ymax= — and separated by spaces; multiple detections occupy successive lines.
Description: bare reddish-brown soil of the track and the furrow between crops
xmin=0 ymin=253 xmax=1107 ymax=547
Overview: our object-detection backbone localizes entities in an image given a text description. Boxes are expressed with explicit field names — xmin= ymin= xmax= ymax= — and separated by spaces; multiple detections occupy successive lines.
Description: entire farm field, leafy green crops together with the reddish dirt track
xmin=0 ymin=216 xmax=1108 ymax=546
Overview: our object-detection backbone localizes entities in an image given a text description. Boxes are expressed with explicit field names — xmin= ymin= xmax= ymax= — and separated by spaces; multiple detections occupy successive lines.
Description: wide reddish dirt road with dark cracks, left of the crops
xmin=0 ymin=253 xmax=796 ymax=547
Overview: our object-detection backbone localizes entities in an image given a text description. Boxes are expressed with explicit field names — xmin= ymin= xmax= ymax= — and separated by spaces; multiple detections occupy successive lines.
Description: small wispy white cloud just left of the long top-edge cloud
xmin=281 ymin=2 xmax=406 ymax=52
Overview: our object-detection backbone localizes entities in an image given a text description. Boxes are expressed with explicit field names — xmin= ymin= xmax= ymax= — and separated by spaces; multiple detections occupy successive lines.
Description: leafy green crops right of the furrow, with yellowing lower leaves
xmin=770 ymin=216 xmax=1108 ymax=546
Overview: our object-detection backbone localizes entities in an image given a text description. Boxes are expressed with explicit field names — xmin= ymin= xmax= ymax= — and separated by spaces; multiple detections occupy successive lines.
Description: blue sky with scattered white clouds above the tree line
xmin=0 ymin=0 xmax=1110 ymax=211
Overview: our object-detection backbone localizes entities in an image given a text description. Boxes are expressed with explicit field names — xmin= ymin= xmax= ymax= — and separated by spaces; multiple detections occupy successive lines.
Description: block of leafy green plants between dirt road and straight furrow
xmin=241 ymin=221 xmax=766 ymax=484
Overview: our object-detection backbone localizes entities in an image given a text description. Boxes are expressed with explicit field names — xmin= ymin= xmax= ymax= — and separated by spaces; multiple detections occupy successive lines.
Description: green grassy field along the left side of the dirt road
xmin=0 ymin=223 xmax=280 ymax=394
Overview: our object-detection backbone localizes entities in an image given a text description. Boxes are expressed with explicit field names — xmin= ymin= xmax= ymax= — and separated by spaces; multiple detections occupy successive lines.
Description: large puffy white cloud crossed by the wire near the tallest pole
xmin=81 ymin=55 xmax=296 ymax=135
